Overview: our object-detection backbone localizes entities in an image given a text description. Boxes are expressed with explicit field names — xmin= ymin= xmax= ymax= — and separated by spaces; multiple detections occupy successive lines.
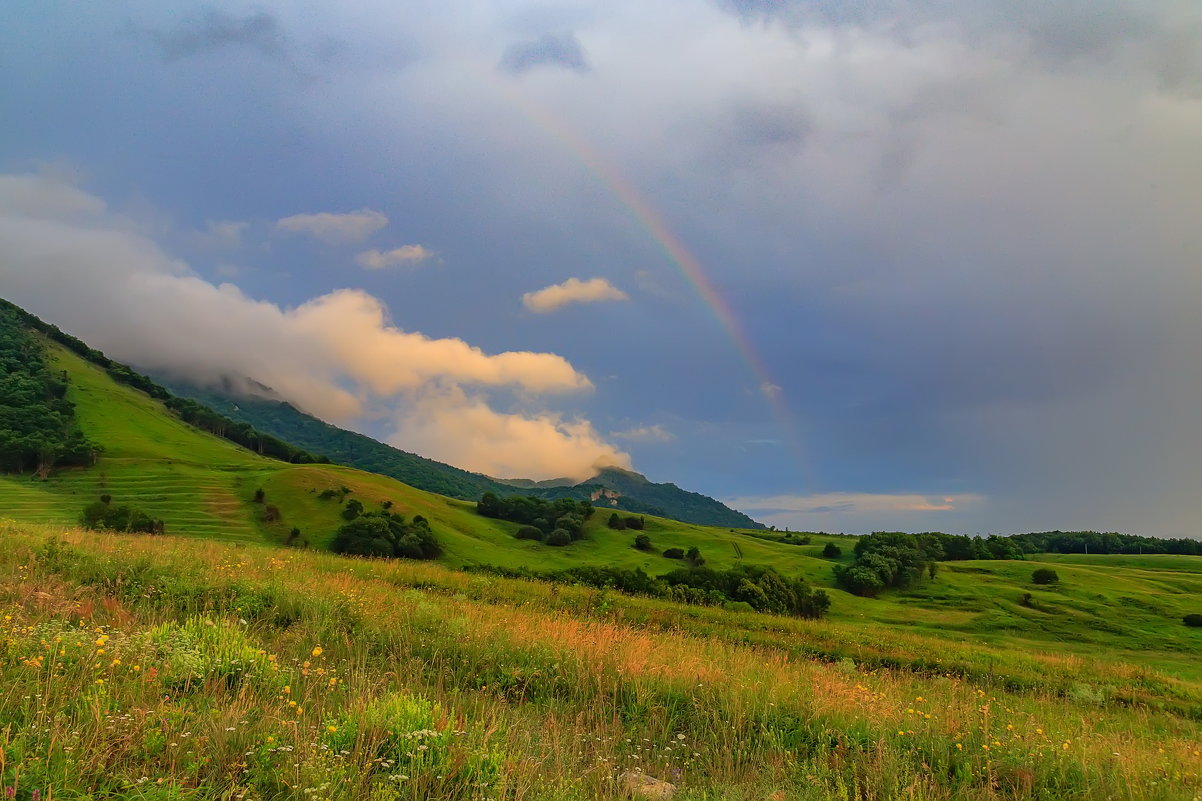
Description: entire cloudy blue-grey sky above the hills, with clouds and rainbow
xmin=0 ymin=0 xmax=1202 ymax=536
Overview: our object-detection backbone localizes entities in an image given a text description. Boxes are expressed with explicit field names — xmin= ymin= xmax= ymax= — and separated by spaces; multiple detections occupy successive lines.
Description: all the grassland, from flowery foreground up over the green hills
xmin=0 ymin=334 xmax=1202 ymax=801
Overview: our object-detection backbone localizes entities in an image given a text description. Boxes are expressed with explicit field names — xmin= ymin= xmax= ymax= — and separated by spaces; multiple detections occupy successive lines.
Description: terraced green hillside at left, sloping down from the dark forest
xmin=0 ymin=305 xmax=783 ymax=576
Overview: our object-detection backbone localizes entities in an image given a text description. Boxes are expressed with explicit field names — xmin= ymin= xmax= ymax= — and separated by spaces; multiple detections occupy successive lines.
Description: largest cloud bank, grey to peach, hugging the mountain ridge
xmin=0 ymin=176 xmax=629 ymax=479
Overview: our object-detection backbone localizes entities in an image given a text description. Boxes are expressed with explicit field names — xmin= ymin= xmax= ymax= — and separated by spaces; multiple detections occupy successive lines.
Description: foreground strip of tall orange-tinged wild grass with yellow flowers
xmin=0 ymin=527 xmax=1202 ymax=801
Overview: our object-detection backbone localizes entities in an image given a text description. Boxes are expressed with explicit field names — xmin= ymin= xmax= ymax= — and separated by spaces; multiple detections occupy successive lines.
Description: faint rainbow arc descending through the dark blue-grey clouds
xmin=489 ymin=71 xmax=810 ymax=479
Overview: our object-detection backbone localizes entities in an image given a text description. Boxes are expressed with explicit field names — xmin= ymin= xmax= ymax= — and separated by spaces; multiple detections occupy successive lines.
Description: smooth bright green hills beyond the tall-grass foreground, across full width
xmin=0 ymin=295 xmax=1202 ymax=665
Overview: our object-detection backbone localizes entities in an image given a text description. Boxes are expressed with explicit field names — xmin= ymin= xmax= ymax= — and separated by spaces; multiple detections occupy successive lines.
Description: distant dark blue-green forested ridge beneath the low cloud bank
xmin=155 ymin=373 xmax=764 ymax=529
